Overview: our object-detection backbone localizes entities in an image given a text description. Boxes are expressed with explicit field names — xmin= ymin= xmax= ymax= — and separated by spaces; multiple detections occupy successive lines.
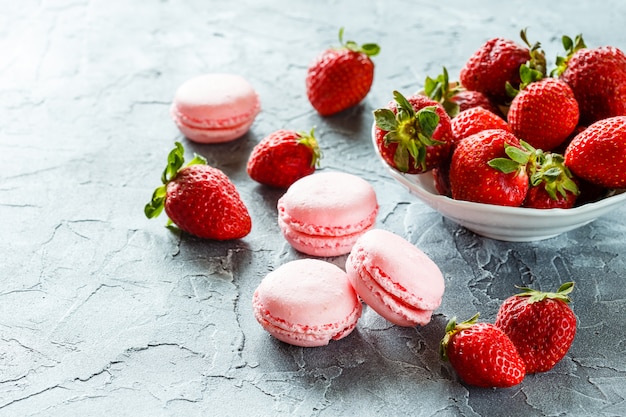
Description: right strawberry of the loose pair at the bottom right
xmin=495 ymin=282 xmax=576 ymax=374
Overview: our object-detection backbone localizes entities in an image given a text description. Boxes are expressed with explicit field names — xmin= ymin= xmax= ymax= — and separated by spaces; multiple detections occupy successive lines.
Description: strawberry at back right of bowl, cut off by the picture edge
xmin=555 ymin=35 xmax=626 ymax=124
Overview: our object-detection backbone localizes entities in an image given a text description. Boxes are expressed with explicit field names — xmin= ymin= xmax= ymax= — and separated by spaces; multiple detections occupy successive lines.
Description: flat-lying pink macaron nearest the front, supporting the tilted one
xmin=252 ymin=259 xmax=362 ymax=347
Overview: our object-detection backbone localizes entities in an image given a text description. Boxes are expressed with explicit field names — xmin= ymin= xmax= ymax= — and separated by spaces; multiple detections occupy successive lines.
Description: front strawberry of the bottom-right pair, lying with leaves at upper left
xmin=440 ymin=314 xmax=526 ymax=388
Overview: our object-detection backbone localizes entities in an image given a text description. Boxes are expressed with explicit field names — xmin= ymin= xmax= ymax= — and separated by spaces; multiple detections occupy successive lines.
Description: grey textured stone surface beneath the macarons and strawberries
xmin=0 ymin=0 xmax=626 ymax=417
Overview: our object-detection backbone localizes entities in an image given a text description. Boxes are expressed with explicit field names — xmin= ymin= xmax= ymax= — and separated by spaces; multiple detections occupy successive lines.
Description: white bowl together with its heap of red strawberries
xmin=372 ymin=30 xmax=626 ymax=241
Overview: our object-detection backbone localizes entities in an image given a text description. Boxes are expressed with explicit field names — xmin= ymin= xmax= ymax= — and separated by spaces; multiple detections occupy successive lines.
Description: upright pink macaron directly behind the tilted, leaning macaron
xmin=278 ymin=172 xmax=378 ymax=256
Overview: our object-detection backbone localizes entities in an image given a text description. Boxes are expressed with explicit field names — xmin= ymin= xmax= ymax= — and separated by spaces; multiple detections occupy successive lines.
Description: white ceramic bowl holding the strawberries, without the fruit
xmin=372 ymin=122 xmax=626 ymax=242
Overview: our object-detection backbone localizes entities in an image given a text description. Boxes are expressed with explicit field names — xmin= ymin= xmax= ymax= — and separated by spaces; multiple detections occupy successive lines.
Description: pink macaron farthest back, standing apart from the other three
xmin=170 ymin=73 xmax=261 ymax=143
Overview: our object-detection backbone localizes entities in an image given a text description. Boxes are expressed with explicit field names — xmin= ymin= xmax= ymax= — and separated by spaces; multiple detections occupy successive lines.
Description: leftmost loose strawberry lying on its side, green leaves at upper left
xmin=144 ymin=142 xmax=252 ymax=240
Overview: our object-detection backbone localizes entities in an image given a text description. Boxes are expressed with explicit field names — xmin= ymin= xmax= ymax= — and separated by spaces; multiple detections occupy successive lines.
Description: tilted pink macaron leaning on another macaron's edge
xmin=346 ymin=229 xmax=444 ymax=327
